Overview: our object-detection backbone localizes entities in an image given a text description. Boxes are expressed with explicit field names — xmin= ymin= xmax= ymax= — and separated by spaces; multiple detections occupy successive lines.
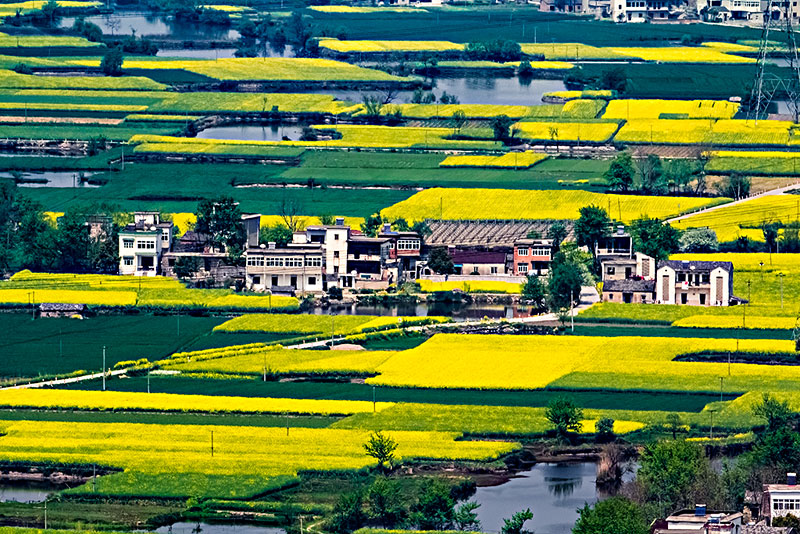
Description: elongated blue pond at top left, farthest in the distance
xmin=61 ymin=11 xmax=239 ymax=41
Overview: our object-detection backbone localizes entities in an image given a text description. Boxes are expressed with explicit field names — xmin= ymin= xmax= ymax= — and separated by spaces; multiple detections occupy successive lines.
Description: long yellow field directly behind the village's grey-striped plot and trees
xmin=381 ymin=188 xmax=725 ymax=222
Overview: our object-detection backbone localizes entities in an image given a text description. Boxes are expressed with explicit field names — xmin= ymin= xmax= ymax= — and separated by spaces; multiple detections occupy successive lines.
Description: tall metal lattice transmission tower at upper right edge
xmin=750 ymin=0 xmax=800 ymax=123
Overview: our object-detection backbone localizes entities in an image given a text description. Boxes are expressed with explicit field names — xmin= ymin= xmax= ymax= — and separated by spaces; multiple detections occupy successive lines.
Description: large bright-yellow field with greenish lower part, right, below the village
xmin=367 ymin=334 xmax=800 ymax=391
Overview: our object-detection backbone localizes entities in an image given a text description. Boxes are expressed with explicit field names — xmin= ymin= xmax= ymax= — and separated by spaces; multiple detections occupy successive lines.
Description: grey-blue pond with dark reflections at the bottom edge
xmin=470 ymin=462 xmax=636 ymax=534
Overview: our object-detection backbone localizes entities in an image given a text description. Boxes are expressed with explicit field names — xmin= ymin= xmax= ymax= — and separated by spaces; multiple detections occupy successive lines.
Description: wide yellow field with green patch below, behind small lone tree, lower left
xmin=0 ymin=420 xmax=518 ymax=498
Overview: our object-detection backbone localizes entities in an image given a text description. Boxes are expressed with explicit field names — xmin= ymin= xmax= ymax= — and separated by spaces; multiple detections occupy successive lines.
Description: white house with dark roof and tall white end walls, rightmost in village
xmin=655 ymin=260 xmax=734 ymax=306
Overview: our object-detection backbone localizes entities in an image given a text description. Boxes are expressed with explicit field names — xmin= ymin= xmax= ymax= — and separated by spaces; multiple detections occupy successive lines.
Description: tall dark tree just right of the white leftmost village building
xmin=195 ymin=196 xmax=246 ymax=258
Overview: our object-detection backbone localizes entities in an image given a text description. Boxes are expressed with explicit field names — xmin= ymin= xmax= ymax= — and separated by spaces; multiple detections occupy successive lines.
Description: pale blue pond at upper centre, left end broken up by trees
xmin=311 ymin=76 xmax=566 ymax=106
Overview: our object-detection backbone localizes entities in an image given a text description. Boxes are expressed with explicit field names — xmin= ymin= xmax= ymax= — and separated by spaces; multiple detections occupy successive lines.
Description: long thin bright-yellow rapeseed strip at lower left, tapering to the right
xmin=0 ymin=389 xmax=392 ymax=415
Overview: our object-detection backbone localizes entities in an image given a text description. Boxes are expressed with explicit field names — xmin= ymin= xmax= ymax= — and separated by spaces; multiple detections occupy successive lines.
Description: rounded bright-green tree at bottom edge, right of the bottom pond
xmin=572 ymin=497 xmax=650 ymax=534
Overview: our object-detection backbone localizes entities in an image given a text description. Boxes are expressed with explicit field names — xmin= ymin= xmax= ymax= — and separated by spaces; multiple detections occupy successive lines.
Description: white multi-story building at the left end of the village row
xmin=119 ymin=211 xmax=174 ymax=276
